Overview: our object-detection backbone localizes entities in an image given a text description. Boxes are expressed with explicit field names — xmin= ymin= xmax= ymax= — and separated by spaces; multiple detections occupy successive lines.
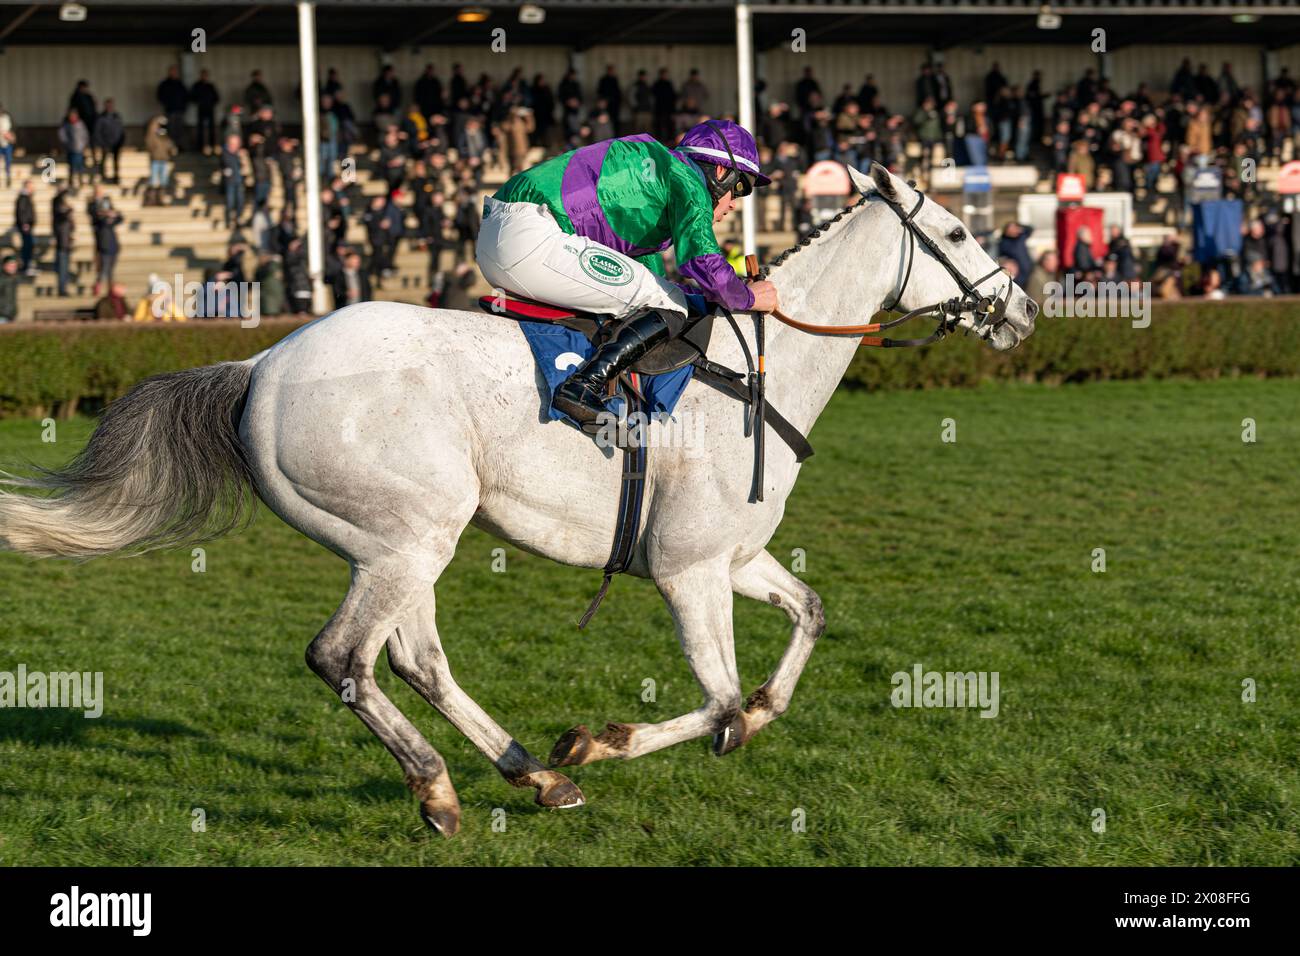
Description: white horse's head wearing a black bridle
xmin=849 ymin=163 xmax=1039 ymax=351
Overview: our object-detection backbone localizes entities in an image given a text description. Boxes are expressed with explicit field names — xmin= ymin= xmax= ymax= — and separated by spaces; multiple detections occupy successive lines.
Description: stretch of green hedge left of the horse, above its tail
xmin=0 ymin=320 xmax=303 ymax=418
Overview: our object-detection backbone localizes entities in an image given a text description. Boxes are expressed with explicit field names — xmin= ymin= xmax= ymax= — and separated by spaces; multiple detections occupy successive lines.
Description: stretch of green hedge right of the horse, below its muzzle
xmin=845 ymin=299 xmax=1300 ymax=389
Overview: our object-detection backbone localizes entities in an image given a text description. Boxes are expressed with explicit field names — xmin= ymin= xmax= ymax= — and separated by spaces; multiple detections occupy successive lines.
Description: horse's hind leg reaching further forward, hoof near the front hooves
xmin=389 ymin=592 xmax=585 ymax=808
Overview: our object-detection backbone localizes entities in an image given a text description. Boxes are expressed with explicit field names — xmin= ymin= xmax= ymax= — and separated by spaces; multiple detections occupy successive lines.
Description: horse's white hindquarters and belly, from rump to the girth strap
xmin=241 ymin=303 xmax=620 ymax=566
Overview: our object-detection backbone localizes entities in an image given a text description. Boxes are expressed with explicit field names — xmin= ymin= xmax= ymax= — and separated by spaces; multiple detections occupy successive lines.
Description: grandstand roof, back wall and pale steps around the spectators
xmin=0 ymin=0 xmax=1300 ymax=321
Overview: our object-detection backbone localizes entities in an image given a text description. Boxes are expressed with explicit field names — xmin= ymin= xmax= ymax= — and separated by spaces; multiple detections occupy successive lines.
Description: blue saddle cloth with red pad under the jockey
xmin=480 ymin=297 xmax=694 ymax=428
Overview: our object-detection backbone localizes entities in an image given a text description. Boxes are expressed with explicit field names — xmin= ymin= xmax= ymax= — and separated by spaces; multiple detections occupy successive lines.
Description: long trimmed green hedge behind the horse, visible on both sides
xmin=0 ymin=299 xmax=1300 ymax=418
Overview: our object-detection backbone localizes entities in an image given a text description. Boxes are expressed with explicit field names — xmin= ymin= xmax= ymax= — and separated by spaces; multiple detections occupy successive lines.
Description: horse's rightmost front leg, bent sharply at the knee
xmin=714 ymin=551 xmax=826 ymax=756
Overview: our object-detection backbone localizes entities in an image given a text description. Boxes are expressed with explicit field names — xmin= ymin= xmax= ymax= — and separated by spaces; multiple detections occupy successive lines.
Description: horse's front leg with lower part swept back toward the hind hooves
xmin=551 ymin=558 xmax=741 ymax=766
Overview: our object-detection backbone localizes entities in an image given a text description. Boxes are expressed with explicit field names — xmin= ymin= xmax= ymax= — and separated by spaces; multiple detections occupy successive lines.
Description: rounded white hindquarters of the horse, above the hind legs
xmin=241 ymin=303 xmax=478 ymax=564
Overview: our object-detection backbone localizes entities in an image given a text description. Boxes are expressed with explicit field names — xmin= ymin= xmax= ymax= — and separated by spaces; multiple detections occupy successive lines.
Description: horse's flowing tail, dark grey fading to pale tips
xmin=0 ymin=359 xmax=256 ymax=558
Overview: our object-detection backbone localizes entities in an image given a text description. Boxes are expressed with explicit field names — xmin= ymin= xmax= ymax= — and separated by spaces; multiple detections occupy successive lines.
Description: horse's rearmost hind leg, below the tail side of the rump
xmin=307 ymin=566 xmax=460 ymax=836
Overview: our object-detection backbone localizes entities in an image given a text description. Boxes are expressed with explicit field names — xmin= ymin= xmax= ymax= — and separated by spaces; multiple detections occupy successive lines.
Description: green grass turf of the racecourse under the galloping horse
xmin=0 ymin=380 xmax=1300 ymax=865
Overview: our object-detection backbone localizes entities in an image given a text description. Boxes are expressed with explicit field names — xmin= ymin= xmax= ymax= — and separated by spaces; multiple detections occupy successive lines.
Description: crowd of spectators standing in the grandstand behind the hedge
xmin=0 ymin=60 xmax=1300 ymax=325
